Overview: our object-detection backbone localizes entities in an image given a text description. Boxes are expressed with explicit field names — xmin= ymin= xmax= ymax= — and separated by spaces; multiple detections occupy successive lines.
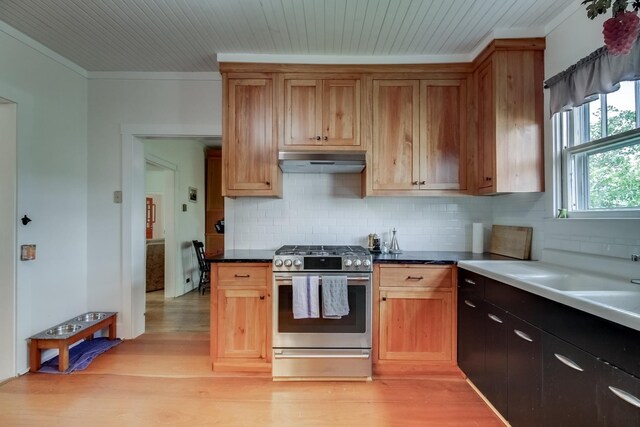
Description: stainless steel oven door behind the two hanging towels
xmin=272 ymin=273 xmax=372 ymax=348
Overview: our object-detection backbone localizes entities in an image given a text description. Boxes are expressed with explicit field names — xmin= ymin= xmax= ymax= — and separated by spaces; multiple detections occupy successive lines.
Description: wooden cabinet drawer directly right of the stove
xmin=380 ymin=266 xmax=452 ymax=288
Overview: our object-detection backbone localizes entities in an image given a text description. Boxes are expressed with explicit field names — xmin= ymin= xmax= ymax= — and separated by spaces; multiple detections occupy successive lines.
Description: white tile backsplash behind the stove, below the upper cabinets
xmin=225 ymin=174 xmax=492 ymax=251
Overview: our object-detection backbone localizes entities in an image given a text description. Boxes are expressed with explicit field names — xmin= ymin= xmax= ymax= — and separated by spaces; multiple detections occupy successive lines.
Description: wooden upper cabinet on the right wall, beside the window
xmin=475 ymin=39 xmax=544 ymax=194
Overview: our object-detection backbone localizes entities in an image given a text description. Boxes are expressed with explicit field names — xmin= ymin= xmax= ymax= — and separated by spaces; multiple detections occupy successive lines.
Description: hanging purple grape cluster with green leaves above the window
xmin=582 ymin=0 xmax=640 ymax=55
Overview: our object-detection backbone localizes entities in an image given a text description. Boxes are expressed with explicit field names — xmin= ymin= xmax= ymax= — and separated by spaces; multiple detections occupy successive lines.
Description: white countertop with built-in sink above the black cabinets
xmin=458 ymin=261 xmax=640 ymax=331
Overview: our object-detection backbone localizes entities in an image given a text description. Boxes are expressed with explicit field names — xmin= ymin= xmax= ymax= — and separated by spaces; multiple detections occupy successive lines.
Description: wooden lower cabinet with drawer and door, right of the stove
xmin=373 ymin=264 xmax=457 ymax=375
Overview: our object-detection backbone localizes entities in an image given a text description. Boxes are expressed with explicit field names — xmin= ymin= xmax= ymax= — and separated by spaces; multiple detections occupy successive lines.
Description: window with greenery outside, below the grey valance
xmin=553 ymin=81 xmax=640 ymax=217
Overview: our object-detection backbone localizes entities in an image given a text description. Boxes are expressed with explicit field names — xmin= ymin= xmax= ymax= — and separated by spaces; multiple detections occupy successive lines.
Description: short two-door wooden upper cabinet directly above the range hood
xmin=283 ymin=77 xmax=360 ymax=148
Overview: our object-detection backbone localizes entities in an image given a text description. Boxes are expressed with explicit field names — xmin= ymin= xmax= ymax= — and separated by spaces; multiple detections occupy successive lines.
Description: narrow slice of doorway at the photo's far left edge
xmin=0 ymin=98 xmax=17 ymax=381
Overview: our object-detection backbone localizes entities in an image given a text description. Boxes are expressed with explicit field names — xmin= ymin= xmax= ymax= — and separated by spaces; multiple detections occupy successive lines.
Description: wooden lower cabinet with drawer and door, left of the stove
xmin=211 ymin=263 xmax=271 ymax=372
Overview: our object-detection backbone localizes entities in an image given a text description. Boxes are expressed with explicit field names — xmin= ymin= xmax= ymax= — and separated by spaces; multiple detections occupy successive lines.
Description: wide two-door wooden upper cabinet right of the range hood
xmin=367 ymin=78 xmax=467 ymax=195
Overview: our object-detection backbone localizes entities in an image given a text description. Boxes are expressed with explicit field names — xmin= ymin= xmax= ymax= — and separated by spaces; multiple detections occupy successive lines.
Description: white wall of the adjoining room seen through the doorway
xmin=144 ymin=139 xmax=205 ymax=295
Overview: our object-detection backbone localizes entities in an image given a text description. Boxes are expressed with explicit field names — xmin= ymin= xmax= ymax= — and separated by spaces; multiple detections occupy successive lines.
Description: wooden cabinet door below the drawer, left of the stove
xmin=218 ymin=289 xmax=270 ymax=359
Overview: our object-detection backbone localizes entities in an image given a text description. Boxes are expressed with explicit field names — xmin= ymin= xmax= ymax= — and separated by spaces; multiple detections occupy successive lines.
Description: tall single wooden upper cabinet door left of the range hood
xmin=225 ymin=79 xmax=278 ymax=196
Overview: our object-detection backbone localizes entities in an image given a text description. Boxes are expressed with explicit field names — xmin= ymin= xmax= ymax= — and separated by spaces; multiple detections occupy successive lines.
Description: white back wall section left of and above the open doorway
xmin=87 ymin=73 xmax=222 ymax=336
